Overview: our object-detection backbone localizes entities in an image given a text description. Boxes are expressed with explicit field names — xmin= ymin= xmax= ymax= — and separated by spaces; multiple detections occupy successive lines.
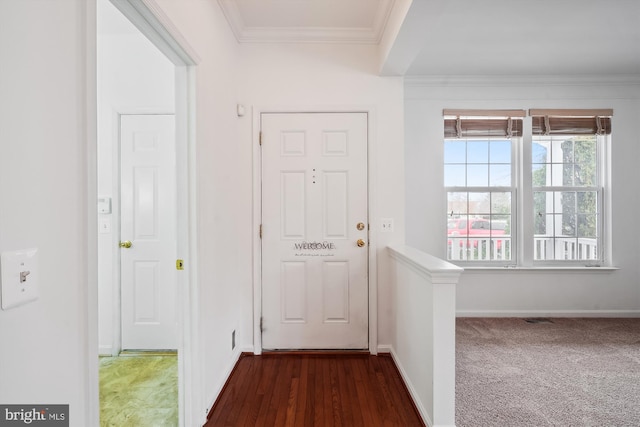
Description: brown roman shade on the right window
xmin=529 ymin=109 xmax=613 ymax=135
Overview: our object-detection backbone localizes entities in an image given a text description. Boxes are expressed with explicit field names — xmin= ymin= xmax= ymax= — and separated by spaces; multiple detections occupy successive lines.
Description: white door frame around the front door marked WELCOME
xmin=253 ymin=106 xmax=378 ymax=354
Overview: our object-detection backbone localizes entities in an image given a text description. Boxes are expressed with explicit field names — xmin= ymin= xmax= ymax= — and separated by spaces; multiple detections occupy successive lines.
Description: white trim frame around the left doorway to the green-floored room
xmin=91 ymin=0 xmax=204 ymax=426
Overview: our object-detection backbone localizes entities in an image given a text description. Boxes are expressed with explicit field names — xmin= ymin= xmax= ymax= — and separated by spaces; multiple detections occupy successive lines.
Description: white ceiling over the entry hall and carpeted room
xmin=218 ymin=0 xmax=640 ymax=76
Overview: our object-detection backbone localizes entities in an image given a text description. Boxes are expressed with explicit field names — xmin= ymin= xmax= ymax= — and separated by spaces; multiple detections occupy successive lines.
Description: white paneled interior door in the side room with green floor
xmin=120 ymin=115 xmax=178 ymax=350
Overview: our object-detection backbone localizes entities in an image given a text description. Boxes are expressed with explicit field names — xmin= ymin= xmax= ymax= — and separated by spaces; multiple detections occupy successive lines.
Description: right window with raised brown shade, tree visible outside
xmin=530 ymin=110 xmax=611 ymax=263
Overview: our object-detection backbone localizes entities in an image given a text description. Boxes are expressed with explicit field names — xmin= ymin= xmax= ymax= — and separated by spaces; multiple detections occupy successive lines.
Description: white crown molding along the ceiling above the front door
xmin=218 ymin=0 xmax=397 ymax=44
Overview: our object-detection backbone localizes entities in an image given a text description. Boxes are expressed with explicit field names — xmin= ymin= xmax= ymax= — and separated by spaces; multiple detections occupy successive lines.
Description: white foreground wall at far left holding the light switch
xmin=0 ymin=0 xmax=97 ymax=427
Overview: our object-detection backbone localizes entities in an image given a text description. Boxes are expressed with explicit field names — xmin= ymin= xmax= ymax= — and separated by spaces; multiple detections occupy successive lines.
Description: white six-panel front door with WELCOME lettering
xmin=261 ymin=113 xmax=368 ymax=350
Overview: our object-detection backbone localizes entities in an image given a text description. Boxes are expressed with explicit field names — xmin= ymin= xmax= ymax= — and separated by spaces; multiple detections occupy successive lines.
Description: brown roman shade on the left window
xmin=442 ymin=109 xmax=526 ymax=138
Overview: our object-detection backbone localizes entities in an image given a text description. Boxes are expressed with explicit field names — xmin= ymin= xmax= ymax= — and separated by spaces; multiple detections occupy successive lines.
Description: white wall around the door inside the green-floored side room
xmin=97 ymin=0 xmax=175 ymax=354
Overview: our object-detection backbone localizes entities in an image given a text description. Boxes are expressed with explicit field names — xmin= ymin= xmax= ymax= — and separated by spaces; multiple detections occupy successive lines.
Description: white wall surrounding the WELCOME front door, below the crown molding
xmin=235 ymin=44 xmax=405 ymax=348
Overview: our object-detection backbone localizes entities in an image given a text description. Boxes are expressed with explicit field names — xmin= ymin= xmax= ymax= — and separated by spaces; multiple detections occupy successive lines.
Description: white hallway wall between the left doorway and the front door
xmin=149 ymin=0 xmax=244 ymax=419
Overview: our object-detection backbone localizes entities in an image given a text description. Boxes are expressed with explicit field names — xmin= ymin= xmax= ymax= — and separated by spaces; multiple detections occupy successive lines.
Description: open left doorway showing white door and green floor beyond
xmin=96 ymin=0 xmax=198 ymax=425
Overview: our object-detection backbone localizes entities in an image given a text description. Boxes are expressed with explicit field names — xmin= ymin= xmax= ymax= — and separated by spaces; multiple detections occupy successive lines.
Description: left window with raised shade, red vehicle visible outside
xmin=444 ymin=110 xmax=525 ymax=263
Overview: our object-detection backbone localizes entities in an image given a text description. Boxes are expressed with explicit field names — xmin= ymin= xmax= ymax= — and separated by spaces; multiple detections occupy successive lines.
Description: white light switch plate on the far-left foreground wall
xmin=0 ymin=248 xmax=40 ymax=310
